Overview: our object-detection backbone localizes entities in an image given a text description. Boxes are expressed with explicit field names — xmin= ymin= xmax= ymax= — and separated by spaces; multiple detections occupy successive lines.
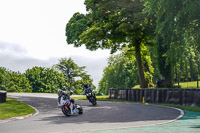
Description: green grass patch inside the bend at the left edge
xmin=0 ymin=98 xmax=35 ymax=120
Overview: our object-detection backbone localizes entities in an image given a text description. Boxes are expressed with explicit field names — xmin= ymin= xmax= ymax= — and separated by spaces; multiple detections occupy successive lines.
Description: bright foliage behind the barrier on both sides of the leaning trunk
xmin=98 ymin=45 xmax=159 ymax=94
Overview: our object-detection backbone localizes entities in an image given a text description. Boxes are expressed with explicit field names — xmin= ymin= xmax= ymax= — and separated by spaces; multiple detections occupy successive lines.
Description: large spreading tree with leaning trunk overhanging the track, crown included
xmin=66 ymin=0 xmax=152 ymax=88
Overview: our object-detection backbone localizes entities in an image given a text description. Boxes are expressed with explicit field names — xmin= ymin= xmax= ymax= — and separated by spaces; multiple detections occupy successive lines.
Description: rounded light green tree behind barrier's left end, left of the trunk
xmin=98 ymin=51 xmax=139 ymax=94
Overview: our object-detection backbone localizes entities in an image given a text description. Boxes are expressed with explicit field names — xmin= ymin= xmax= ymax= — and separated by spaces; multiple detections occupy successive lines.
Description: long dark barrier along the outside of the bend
xmin=109 ymin=89 xmax=200 ymax=106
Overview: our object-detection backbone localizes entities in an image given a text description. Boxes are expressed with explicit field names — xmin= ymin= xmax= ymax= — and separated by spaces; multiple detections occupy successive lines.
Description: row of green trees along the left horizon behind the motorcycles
xmin=0 ymin=58 xmax=95 ymax=94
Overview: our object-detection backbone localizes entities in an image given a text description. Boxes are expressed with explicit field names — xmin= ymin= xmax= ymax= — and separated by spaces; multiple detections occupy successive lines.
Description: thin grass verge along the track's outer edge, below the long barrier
xmin=73 ymin=96 xmax=200 ymax=112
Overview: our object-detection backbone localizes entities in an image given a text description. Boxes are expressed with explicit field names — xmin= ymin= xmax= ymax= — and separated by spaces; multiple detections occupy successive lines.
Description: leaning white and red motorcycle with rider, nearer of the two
xmin=57 ymin=89 xmax=83 ymax=116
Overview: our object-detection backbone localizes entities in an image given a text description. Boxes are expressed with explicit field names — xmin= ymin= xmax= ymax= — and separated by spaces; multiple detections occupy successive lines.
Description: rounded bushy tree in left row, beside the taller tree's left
xmin=25 ymin=67 xmax=67 ymax=93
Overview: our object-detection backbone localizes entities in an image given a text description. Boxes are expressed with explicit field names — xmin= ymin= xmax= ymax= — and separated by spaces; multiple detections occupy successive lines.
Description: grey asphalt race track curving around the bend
xmin=0 ymin=93 xmax=181 ymax=133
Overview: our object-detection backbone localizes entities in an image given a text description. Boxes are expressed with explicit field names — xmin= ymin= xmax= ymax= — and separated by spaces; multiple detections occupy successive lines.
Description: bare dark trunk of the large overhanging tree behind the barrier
xmin=135 ymin=41 xmax=147 ymax=88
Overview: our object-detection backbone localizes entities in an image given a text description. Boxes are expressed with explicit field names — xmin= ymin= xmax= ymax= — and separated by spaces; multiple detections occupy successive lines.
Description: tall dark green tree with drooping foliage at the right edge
xmin=144 ymin=0 xmax=200 ymax=87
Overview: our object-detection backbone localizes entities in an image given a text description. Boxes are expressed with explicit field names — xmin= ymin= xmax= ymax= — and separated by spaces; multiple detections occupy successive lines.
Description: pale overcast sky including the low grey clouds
xmin=0 ymin=0 xmax=109 ymax=86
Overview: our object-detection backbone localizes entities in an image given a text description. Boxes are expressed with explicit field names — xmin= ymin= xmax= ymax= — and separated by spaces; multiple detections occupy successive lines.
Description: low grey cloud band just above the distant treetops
xmin=0 ymin=42 xmax=110 ymax=86
